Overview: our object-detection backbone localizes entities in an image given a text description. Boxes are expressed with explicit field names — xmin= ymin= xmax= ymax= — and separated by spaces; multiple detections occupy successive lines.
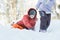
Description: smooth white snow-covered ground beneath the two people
xmin=0 ymin=20 xmax=60 ymax=40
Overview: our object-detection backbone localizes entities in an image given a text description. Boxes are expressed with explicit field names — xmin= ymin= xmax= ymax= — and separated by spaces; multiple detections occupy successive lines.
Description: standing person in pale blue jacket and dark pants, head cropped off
xmin=36 ymin=0 xmax=55 ymax=32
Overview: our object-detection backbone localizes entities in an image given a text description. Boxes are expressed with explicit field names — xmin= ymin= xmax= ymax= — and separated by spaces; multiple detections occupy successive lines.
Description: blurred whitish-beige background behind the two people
xmin=0 ymin=0 xmax=60 ymax=25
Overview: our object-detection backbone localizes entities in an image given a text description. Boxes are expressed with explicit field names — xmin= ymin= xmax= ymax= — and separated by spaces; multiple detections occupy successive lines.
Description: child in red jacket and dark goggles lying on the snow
xmin=12 ymin=8 xmax=37 ymax=29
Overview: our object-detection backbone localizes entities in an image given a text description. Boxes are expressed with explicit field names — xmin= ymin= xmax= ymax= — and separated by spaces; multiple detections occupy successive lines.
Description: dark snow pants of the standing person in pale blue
xmin=39 ymin=11 xmax=51 ymax=30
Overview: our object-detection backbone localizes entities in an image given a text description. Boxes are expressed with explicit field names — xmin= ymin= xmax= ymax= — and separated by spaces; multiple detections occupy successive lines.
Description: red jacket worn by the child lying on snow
xmin=17 ymin=15 xmax=37 ymax=28
